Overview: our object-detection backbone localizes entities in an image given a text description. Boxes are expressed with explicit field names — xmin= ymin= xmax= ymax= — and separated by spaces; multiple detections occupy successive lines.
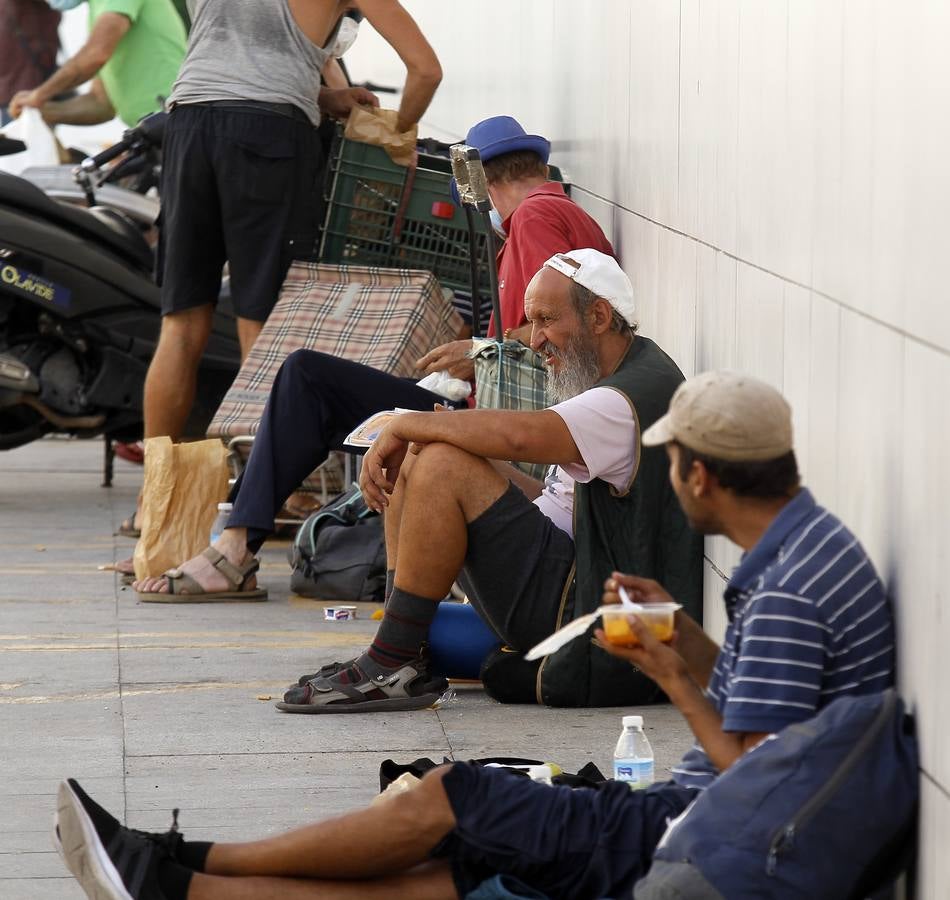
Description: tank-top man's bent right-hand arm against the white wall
xmin=357 ymin=0 xmax=442 ymax=131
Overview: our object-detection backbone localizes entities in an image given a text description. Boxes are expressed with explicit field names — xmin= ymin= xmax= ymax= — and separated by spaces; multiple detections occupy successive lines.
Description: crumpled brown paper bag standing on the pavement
xmin=132 ymin=437 xmax=228 ymax=579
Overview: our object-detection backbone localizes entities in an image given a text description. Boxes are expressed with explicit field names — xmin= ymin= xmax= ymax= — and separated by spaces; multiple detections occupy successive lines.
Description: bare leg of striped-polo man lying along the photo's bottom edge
xmin=188 ymin=850 xmax=458 ymax=900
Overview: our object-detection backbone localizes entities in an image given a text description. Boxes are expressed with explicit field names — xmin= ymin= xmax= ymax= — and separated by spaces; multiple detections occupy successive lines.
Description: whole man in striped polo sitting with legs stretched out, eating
xmin=56 ymin=374 xmax=894 ymax=900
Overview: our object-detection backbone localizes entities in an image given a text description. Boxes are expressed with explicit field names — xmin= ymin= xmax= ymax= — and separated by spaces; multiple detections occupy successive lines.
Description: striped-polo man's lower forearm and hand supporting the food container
xmin=595 ymin=618 xmax=768 ymax=772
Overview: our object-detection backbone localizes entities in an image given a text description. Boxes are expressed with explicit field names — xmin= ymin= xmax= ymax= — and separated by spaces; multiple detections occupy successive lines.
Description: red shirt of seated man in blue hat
xmin=488 ymin=181 xmax=614 ymax=336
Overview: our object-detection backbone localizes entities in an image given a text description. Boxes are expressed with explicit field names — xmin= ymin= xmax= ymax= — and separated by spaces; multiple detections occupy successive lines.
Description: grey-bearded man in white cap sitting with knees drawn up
xmin=278 ymin=249 xmax=702 ymax=713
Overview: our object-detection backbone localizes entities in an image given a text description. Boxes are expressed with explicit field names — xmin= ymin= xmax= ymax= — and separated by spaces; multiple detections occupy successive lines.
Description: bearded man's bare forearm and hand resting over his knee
xmin=360 ymin=409 xmax=583 ymax=511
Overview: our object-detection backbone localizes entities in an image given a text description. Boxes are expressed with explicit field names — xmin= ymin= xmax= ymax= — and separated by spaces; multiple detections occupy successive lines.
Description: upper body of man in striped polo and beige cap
xmin=604 ymin=372 xmax=894 ymax=788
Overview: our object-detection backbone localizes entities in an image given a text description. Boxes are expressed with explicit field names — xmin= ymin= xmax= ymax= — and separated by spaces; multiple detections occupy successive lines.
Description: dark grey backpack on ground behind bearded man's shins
xmin=289 ymin=485 xmax=386 ymax=603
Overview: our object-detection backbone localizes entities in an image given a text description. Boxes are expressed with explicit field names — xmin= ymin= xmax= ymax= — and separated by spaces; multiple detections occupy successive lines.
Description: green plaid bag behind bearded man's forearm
xmin=472 ymin=338 xmax=550 ymax=481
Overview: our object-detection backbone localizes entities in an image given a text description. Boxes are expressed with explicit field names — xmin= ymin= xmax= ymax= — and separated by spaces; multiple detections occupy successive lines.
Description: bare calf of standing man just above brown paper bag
xmin=144 ymin=303 xmax=214 ymax=441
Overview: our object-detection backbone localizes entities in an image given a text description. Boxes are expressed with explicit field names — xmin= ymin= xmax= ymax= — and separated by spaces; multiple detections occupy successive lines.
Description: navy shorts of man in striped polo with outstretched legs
xmin=432 ymin=763 xmax=697 ymax=900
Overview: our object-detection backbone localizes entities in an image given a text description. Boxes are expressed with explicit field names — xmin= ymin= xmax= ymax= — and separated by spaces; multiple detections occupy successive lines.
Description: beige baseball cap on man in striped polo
xmin=642 ymin=372 xmax=792 ymax=462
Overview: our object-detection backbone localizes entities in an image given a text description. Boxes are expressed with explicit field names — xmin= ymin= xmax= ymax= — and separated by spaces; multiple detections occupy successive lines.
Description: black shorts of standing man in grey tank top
xmin=157 ymin=103 xmax=324 ymax=322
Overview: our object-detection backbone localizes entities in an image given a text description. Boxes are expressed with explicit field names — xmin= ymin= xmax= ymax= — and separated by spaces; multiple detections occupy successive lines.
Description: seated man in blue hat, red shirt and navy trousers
xmin=132 ymin=116 xmax=613 ymax=602
